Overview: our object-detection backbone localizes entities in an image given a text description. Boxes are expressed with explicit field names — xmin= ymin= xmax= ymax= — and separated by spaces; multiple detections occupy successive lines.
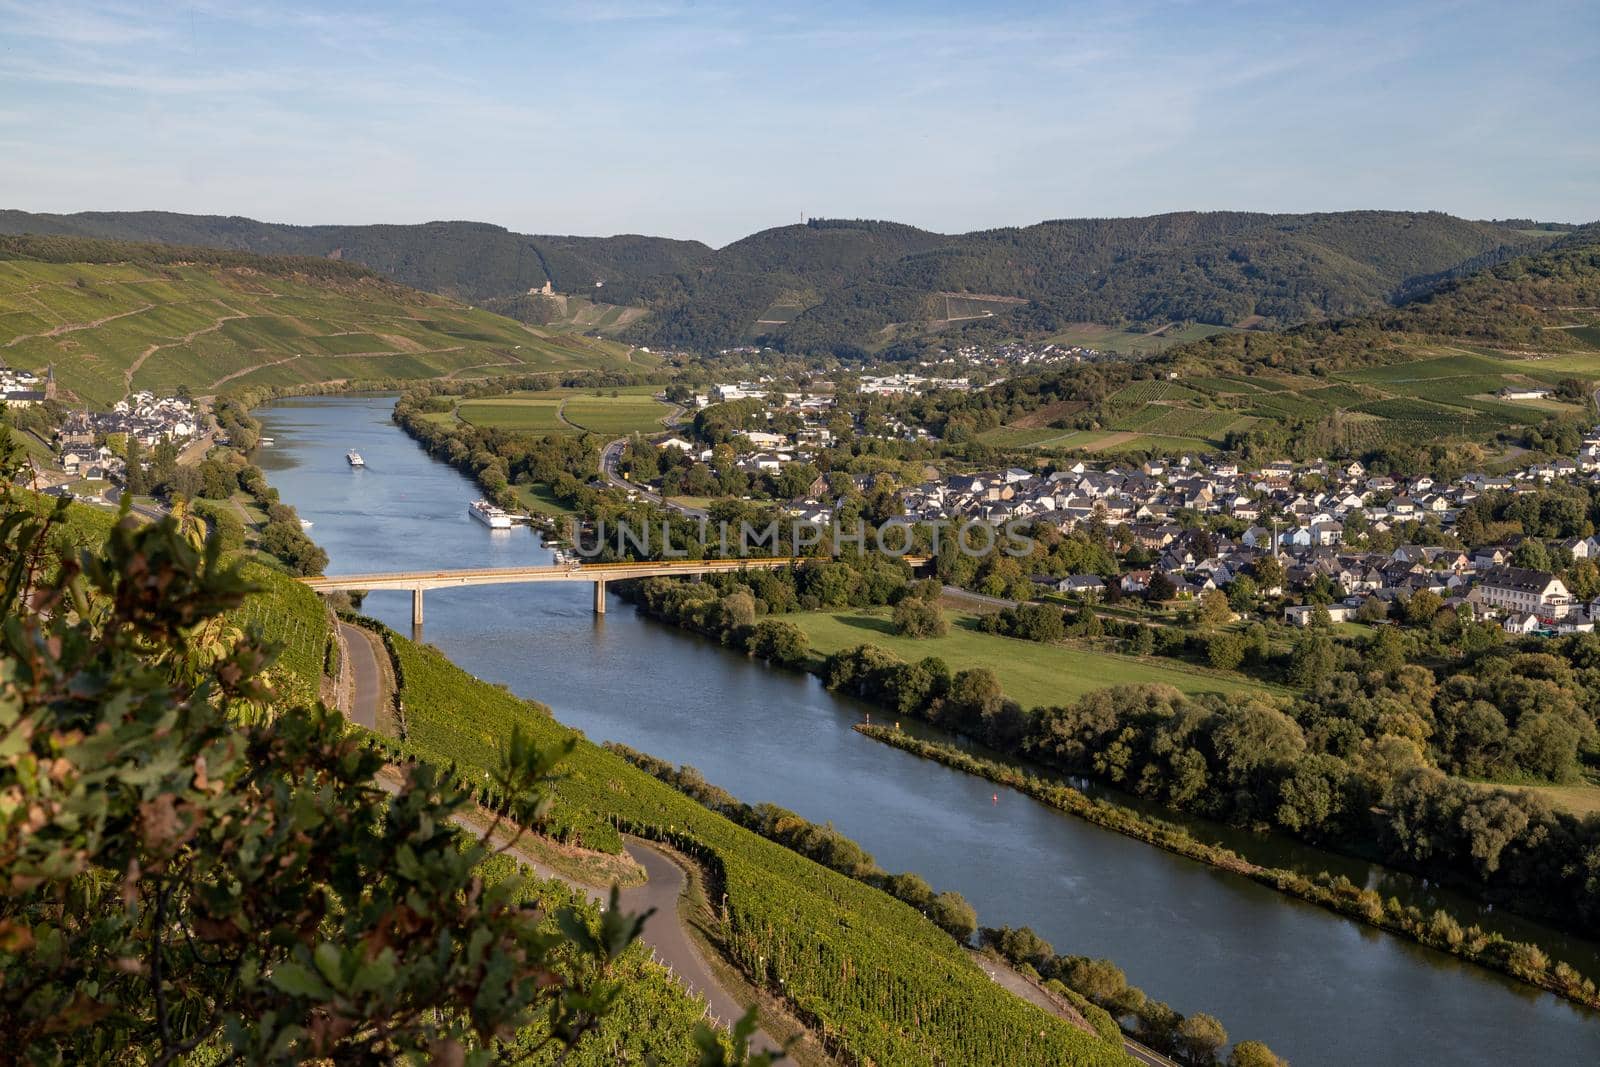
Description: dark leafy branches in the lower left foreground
xmin=0 ymin=460 xmax=675 ymax=1064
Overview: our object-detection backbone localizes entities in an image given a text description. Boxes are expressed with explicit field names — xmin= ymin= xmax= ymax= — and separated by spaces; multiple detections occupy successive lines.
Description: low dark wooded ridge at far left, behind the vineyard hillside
xmin=0 ymin=211 xmax=710 ymax=301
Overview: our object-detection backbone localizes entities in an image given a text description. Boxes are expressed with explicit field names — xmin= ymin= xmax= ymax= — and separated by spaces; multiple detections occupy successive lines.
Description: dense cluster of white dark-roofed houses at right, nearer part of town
xmin=902 ymin=434 xmax=1600 ymax=633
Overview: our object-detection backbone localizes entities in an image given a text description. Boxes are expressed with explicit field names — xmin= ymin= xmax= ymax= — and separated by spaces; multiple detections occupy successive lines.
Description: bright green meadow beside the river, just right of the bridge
xmin=784 ymin=611 xmax=1269 ymax=707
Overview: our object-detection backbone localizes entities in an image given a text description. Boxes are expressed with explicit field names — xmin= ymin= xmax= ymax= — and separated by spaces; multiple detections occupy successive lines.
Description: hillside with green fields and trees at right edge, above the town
xmin=979 ymin=227 xmax=1600 ymax=459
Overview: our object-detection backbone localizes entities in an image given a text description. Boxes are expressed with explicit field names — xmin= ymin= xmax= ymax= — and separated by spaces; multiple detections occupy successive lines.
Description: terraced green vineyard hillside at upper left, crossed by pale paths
xmin=0 ymin=237 xmax=648 ymax=406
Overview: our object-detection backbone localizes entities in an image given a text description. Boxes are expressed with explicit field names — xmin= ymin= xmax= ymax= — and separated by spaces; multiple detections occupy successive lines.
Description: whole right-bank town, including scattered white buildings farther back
xmin=658 ymin=376 xmax=1600 ymax=635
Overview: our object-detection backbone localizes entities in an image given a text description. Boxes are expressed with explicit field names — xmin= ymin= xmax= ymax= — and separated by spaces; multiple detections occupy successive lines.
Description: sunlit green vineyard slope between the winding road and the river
xmin=384 ymin=632 xmax=1130 ymax=1067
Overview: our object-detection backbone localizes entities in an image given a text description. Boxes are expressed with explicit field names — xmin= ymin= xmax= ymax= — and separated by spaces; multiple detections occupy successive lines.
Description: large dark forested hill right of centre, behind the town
xmin=638 ymin=211 xmax=1558 ymax=350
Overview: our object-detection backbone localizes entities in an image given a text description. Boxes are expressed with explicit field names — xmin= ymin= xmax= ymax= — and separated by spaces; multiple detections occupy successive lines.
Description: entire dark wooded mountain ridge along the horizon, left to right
xmin=0 ymin=211 xmax=1565 ymax=354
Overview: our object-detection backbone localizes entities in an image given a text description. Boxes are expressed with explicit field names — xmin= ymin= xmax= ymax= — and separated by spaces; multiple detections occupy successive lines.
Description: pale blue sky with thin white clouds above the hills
xmin=0 ymin=0 xmax=1600 ymax=246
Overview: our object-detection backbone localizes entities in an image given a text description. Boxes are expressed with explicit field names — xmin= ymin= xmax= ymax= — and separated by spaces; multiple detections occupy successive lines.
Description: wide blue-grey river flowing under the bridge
xmin=256 ymin=397 xmax=1600 ymax=1067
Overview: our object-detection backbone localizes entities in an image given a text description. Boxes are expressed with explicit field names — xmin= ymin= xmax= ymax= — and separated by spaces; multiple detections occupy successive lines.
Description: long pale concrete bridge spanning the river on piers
xmin=301 ymin=555 xmax=928 ymax=625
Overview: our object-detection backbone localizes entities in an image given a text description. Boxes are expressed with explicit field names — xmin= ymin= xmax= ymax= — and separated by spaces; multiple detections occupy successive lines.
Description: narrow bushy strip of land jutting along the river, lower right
xmin=856 ymin=723 xmax=1600 ymax=1011
